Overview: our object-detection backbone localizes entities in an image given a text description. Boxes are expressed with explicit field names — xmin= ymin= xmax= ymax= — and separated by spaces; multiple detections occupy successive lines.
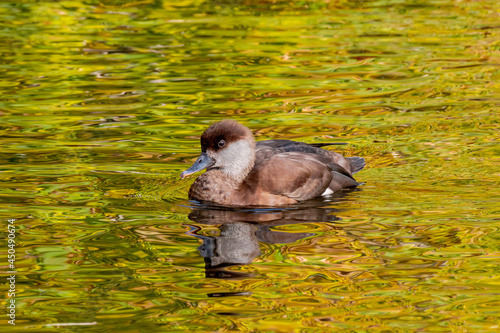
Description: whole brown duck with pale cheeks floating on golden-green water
xmin=181 ymin=119 xmax=365 ymax=207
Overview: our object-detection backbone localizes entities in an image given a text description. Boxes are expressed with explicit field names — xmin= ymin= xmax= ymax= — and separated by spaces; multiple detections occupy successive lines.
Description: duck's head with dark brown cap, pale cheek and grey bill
xmin=181 ymin=120 xmax=255 ymax=182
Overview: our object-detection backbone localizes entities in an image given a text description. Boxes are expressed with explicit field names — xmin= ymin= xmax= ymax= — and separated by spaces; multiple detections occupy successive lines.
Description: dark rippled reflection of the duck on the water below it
xmin=184 ymin=198 xmax=339 ymax=279
